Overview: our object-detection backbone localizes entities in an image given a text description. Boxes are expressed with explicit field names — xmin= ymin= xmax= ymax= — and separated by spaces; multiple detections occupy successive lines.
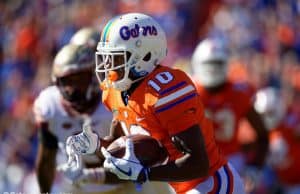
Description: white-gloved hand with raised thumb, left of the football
xmin=66 ymin=123 xmax=100 ymax=154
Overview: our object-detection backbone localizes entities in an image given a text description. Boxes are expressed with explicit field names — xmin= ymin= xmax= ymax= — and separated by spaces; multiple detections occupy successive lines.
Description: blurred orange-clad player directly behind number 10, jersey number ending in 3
xmin=191 ymin=38 xmax=268 ymax=173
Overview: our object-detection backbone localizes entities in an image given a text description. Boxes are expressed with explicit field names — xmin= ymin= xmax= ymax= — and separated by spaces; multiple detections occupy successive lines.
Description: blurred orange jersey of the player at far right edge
xmin=270 ymin=110 xmax=300 ymax=185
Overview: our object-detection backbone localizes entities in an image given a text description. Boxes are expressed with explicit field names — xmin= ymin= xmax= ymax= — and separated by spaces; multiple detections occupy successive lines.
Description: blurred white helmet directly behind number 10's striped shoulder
xmin=191 ymin=38 xmax=228 ymax=88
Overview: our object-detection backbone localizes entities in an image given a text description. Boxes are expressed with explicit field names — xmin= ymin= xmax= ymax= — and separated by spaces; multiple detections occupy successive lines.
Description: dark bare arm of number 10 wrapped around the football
xmin=145 ymin=125 xmax=209 ymax=182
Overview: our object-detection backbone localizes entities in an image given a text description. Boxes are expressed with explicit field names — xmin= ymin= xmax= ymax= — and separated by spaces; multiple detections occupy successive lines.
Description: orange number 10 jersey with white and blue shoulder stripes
xmin=103 ymin=66 xmax=226 ymax=193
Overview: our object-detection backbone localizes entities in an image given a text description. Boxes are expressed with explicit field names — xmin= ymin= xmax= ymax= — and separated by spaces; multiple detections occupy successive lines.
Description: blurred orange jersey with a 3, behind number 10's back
xmin=195 ymin=78 xmax=254 ymax=156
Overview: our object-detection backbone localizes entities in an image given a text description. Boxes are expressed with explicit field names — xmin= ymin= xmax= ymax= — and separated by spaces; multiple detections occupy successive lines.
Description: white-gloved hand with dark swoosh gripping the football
xmin=101 ymin=138 xmax=149 ymax=182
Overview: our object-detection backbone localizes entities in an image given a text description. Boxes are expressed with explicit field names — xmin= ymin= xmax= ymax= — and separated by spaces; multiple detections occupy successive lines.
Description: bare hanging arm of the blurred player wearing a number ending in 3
xmin=246 ymin=107 xmax=269 ymax=167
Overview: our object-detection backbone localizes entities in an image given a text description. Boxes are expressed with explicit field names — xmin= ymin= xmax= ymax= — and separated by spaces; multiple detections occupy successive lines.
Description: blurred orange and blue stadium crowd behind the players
xmin=0 ymin=0 xmax=300 ymax=193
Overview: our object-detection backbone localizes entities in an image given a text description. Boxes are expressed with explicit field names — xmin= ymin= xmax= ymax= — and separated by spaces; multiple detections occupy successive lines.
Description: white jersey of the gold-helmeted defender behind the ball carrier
xmin=34 ymin=86 xmax=112 ymax=163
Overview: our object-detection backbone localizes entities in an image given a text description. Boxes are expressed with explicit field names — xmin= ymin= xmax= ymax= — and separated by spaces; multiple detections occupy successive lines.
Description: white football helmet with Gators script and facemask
xmin=96 ymin=13 xmax=167 ymax=91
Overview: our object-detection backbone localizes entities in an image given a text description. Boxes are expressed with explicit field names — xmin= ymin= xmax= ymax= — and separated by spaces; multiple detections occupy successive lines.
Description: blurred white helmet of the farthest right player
xmin=254 ymin=87 xmax=287 ymax=130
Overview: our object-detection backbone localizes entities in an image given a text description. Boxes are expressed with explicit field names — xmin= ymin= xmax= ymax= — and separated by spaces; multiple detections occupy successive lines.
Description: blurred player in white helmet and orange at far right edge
xmin=255 ymin=87 xmax=300 ymax=194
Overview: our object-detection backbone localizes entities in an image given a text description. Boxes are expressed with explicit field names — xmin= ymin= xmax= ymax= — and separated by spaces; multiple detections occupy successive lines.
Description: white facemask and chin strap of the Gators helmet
xmin=96 ymin=44 xmax=156 ymax=91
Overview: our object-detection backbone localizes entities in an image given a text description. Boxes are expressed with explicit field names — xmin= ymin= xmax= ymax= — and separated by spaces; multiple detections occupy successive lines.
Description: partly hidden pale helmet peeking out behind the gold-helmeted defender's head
xmin=70 ymin=27 xmax=100 ymax=49
